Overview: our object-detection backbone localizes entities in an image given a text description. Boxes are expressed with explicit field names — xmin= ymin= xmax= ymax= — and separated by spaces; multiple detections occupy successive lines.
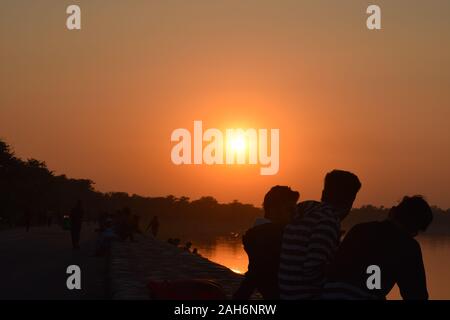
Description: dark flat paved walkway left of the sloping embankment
xmin=0 ymin=226 xmax=107 ymax=300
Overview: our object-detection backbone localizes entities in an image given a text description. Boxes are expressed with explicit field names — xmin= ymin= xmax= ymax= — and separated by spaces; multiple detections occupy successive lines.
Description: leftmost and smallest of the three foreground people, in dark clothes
xmin=233 ymin=186 xmax=300 ymax=300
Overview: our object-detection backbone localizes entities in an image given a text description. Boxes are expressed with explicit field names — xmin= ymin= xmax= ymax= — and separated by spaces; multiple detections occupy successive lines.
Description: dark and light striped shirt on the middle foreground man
xmin=278 ymin=201 xmax=340 ymax=300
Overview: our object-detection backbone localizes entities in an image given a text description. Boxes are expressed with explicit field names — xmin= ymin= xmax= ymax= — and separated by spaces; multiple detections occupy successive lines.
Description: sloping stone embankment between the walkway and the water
xmin=109 ymin=236 xmax=248 ymax=300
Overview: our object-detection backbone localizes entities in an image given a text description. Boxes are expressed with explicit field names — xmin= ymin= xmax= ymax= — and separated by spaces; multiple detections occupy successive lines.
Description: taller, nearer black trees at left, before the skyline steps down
xmin=0 ymin=140 xmax=102 ymax=226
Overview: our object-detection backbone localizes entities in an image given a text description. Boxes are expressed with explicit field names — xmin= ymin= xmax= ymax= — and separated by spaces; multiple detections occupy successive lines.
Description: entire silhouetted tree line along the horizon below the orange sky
xmin=0 ymin=140 xmax=450 ymax=236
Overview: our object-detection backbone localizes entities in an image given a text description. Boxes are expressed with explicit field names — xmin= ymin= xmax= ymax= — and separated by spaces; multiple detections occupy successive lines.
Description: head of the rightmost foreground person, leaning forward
xmin=389 ymin=196 xmax=433 ymax=236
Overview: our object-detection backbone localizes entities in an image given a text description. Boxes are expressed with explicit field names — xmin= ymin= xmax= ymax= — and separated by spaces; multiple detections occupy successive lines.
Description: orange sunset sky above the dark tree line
xmin=0 ymin=0 xmax=450 ymax=208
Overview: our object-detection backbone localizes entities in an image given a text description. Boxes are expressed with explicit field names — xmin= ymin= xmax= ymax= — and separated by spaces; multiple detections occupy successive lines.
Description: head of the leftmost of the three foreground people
xmin=263 ymin=186 xmax=300 ymax=223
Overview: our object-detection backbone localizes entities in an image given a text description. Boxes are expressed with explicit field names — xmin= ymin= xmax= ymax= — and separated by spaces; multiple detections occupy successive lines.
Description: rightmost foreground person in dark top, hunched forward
xmin=323 ymin=196 xmax=433 ymax=300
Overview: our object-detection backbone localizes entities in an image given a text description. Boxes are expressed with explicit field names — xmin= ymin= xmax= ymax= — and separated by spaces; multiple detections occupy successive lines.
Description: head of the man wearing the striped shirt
xmin=322 ymin=170 xmax=361 ymax=219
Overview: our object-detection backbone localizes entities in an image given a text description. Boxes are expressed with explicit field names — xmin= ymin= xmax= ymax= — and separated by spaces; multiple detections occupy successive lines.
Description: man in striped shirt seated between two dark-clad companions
xmin=278 ymin=170 xmax=361 ymax=300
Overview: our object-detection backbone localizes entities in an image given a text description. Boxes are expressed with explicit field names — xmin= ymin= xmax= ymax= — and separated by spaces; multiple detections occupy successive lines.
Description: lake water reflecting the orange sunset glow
xmin=193 ymin=235 xmax=450 ymax=300
